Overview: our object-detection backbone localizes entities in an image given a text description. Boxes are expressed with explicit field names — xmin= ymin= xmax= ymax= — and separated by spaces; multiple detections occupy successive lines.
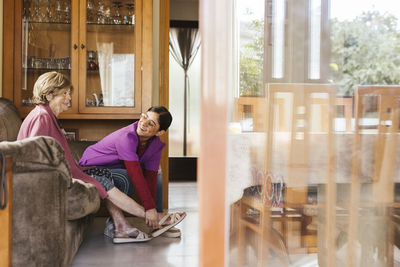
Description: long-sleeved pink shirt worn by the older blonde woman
xmin=17 ymin=105 xmax=108 ymax=199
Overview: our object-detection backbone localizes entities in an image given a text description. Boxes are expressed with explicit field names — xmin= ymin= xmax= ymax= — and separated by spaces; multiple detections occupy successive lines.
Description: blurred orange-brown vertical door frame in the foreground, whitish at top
xmin=197 ymin=0 xmax=230 ymax=267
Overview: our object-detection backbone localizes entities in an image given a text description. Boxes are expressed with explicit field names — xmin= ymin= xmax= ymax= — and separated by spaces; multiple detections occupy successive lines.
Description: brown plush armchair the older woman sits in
xmin=0 ymin=98 xmax=100 ymax=266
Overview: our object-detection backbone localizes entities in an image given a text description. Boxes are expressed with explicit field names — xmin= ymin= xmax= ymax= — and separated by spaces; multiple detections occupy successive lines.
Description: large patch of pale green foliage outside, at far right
xmin=330 ymin=11 xmax=400 ymax=95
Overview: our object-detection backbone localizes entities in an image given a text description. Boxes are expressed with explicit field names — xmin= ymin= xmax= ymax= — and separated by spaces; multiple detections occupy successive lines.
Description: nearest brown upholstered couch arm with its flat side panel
xmin=0 ymin=137 xmax=71 ymax=266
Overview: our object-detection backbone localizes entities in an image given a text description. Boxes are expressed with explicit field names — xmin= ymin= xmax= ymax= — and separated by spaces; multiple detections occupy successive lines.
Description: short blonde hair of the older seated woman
xmin=32 ymin=71 xmax=73 ymax=105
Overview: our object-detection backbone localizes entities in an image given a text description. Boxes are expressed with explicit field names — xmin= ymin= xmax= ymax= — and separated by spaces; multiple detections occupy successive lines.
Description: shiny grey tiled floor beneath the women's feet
xmin=71 ymin=182 xmax=199 ymax=267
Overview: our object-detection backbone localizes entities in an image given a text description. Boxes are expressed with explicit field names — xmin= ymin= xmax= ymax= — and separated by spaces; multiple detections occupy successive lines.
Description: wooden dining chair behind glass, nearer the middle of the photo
xmin=238 ymin=84 xmax=336 ymax=266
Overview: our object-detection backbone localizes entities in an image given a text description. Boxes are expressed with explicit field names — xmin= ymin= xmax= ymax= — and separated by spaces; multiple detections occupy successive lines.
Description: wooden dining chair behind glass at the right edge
xmin=346 ymin=85 xmax=400 ymax=266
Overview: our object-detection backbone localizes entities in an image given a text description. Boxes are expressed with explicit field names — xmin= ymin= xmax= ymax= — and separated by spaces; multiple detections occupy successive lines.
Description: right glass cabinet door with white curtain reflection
xmin=79 ymin=0 xmax=141 ymax=113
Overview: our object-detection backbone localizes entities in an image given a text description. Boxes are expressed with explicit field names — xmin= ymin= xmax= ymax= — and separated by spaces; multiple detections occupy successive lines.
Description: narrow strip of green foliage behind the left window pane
xmin=239 ymin=20 xmax=264 ymax=96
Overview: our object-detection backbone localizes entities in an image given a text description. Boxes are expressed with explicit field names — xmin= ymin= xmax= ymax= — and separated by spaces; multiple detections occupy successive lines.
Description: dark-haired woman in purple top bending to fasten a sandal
xmin=79 ymin=106 xmax=185 ymax=240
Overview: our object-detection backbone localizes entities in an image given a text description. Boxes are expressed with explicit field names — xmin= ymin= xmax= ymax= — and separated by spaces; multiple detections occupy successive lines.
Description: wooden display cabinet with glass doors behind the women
xmin=3 ymin=0 xmax=153 ymax=119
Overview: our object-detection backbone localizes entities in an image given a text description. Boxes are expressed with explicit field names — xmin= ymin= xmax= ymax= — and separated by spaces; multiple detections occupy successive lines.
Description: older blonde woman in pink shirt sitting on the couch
xmin=18 ymin=72 xmax=185 ymax=243
